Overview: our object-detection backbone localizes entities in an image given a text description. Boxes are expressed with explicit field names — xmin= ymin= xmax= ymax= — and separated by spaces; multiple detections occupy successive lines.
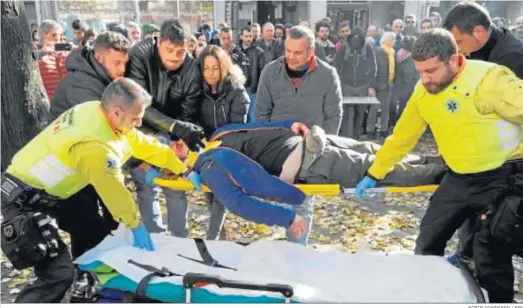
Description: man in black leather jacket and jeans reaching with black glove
xmin=125 ymin=20 xmax=204 ymax=237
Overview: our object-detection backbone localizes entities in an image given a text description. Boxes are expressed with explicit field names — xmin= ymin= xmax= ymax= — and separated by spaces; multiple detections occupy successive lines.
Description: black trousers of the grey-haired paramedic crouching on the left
xmin=2 ymin=186 xmax=118 ymax=303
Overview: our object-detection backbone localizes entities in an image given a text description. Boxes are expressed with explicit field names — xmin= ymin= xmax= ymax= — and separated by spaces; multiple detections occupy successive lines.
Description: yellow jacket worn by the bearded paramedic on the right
xmin=368 ymin=60 xmax=523 ymax=179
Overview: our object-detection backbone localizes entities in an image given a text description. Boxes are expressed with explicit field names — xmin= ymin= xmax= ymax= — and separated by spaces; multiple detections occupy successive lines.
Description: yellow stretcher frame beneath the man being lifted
xmin=154 ymin=179 xmax=438 ymax=196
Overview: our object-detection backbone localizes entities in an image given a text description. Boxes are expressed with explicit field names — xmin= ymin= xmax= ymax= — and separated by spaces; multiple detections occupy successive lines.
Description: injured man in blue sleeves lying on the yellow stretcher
xmin=161 ymin=121 xmax=446 ymax=236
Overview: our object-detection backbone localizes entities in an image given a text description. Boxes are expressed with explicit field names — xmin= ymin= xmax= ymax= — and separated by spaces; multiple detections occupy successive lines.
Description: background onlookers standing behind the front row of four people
xmin=33 ymin=12 xmax=523 ymax=138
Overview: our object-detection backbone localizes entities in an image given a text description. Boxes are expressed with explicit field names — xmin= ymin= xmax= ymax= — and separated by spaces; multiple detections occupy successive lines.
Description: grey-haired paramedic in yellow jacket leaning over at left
xmin=2 ymin=78 xmax=198 ymax=303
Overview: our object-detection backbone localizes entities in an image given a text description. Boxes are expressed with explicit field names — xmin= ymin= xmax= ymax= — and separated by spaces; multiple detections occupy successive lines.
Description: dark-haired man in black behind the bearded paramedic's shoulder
xmin=443 ymin=2 xmax=523 ymax=263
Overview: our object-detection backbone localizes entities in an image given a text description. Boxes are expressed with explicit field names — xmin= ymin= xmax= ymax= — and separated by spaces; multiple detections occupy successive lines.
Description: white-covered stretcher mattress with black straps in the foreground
xmin=75 ymin=226 xmax=488 ymax=303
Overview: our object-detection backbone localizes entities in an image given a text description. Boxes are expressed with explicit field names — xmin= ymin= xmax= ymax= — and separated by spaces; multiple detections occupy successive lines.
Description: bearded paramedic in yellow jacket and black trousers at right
xmin=356 ymin=29 xmax=523 ymax=302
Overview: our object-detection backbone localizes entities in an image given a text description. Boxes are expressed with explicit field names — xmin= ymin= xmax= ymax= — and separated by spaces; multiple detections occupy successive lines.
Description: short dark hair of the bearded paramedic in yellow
xmin=412 ymin=28 xmax=458 ymax=63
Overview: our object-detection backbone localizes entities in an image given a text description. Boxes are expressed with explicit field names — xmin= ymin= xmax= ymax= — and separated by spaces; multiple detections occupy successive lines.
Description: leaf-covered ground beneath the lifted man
xmin=1 ymin=138 xmax=523 ymax=303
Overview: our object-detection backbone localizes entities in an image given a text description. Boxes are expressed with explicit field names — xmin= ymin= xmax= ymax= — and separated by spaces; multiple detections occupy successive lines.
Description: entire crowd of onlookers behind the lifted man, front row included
xmin=30 ymin=3 xmax=523 ymax=245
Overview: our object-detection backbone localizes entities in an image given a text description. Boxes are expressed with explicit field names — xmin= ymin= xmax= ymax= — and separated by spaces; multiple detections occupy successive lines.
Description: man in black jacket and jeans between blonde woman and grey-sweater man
xmin=240 ymin=27 xmax=265 ymax=123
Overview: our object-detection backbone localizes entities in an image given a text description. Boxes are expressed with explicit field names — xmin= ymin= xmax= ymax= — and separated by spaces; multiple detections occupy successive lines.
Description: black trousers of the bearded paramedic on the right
xmin=415 ymin=162 xmax=523 ymax=303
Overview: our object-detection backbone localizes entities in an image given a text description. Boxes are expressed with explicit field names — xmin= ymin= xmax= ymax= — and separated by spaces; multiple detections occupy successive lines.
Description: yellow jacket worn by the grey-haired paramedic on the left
xmin=7 ymin=101 xmax=187 ymax=228
